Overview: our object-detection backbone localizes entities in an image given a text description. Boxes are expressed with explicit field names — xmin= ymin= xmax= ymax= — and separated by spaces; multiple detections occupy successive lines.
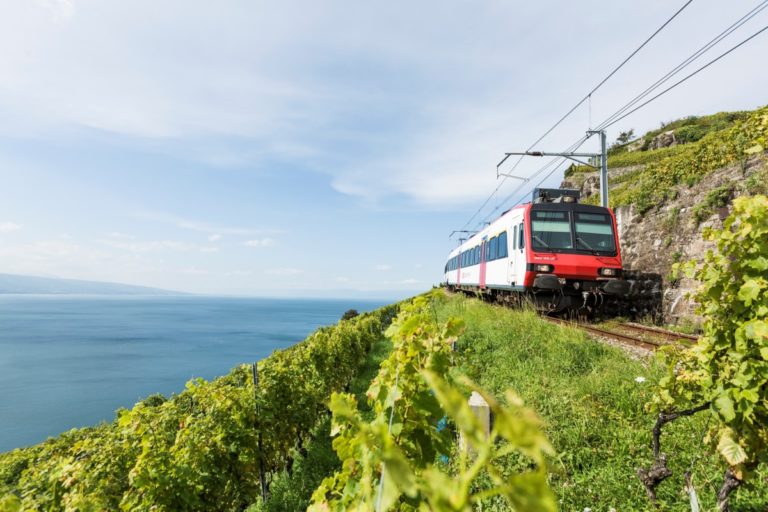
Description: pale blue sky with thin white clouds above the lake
xmin=0 ymin=0 xmax=768 ymax=298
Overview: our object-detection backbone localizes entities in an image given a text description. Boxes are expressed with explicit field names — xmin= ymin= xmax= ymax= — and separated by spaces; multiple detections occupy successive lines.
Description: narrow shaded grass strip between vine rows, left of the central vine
xmin=255 ymin=336 xmax=392 ymax=512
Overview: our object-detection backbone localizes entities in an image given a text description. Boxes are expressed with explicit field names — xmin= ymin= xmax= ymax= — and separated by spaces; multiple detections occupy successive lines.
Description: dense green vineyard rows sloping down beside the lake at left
xmin=0 ymin=305 xmax=397 ymax=512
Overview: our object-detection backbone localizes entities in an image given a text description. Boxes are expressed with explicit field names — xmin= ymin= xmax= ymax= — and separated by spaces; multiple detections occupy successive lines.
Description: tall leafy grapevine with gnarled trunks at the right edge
xmin=638 ymin=196 xmax=768 ymax=511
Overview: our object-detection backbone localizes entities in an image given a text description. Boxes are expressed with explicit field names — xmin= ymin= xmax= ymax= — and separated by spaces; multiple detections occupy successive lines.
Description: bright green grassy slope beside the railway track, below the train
xmin=437 ymin=296 xmax=768 ymax=511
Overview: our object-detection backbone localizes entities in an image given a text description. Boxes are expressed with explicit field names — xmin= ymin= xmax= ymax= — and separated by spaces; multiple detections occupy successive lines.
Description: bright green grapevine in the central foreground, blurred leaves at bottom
xmin=309 ymin=295 xmax=556 ymax=512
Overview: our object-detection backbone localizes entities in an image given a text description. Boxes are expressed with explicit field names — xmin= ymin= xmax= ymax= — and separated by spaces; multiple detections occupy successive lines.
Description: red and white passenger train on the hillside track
xmin=444 ymin=188 xmax=630 ymax=313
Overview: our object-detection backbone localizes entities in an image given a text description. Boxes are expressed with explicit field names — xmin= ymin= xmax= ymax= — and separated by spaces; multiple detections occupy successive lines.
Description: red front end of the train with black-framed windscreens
xmin=525 ymin=189 xmax=629 ymax=310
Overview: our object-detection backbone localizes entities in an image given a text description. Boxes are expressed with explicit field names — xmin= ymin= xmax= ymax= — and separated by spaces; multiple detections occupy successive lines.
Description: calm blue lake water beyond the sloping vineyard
xmin=0 ymin=295 xmax=384 ymax=451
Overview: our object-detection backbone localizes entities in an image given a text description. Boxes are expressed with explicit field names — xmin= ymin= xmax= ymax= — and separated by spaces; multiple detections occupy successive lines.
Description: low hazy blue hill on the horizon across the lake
xmin=0 ymin=274 xmax=185 ymax=295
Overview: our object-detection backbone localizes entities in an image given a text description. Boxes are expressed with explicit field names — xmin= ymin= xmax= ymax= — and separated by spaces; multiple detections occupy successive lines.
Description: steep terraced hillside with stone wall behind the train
xmin=561 ymin=107 xmax=768 ymax=324
